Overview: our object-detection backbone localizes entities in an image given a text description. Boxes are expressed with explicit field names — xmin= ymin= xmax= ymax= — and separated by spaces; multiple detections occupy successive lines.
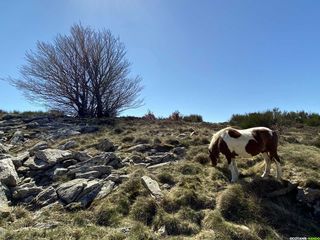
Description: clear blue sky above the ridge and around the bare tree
xmin=0 ymin=0 xmax=320 ymax=122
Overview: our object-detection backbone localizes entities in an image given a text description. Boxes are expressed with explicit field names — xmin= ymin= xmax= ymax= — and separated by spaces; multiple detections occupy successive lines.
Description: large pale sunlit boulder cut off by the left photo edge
xmin=0 ymin=158 xmax=20 ymax=187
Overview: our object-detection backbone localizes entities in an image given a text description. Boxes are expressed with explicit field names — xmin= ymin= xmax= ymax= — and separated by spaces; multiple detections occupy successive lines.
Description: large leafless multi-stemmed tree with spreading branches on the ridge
xmin=11 ymin=24 xmax=142 ymax=117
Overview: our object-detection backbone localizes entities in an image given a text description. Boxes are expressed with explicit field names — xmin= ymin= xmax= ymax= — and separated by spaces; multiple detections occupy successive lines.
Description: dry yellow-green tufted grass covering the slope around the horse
xmin=0 ymin=119 xmax=320 ymax=239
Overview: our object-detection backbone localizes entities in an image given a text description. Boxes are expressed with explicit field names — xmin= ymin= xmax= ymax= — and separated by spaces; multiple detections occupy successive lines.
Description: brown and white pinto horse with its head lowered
xmin=209 ymin=127 xmax=282 ymax=182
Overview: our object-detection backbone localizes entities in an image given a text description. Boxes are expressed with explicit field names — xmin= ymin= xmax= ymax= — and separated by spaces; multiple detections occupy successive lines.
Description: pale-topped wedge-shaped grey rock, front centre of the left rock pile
xmin=57 ymin=178 xmax=87 ymax=204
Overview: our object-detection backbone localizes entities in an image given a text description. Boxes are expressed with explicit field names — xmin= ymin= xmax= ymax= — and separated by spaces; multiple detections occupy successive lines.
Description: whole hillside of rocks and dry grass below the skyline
xmin=0 ymin=114 xmax=320 ymax=240
